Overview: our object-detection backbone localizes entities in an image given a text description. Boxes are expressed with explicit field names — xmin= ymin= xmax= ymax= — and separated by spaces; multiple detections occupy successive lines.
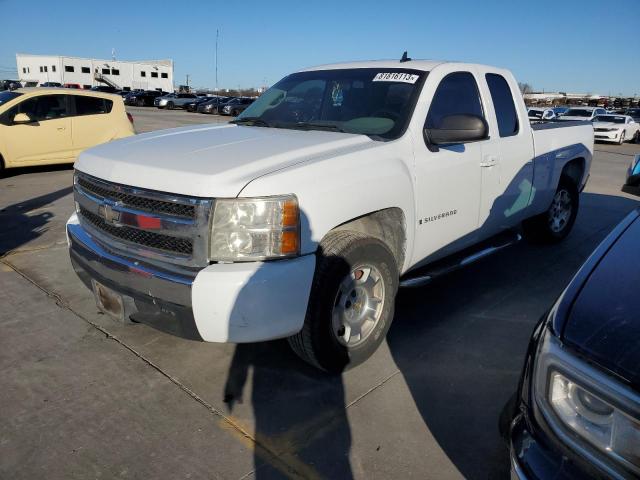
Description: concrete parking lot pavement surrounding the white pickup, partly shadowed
xmin=0 ymin=108 xmax=640 ymax=479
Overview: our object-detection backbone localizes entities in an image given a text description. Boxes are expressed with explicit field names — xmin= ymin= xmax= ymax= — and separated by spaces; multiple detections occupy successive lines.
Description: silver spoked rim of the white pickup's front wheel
xmin=332 ymin=265 xmax=385 ymax=347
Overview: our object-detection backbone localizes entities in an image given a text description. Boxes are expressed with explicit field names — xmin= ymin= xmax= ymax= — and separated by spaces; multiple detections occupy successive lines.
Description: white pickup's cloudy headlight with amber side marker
xmin=210 ymin=195 xmax=300 ymax=262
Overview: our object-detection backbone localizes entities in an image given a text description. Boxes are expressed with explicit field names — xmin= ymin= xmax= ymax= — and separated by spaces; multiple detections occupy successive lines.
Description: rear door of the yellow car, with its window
xmin=71 ymin=95 xmax=116 ymax=156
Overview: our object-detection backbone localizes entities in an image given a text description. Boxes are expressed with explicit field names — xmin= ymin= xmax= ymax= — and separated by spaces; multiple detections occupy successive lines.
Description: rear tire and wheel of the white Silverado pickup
xmin=522 ymin=175 xmax=580 ymax=243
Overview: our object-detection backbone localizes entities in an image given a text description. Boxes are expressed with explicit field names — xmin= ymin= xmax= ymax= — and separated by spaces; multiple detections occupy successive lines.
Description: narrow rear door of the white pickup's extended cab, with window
xmin=479 ymin=71 xmax=534 ymax=238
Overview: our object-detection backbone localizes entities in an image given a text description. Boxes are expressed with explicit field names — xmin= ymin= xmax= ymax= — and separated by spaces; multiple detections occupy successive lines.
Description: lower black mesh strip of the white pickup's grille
xmin=80 ymin=207 xmax=193 ymax=255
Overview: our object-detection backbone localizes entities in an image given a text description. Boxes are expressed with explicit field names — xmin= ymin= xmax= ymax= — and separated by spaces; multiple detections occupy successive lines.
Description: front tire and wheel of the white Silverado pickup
xmin=288 ymin=231 xmax=398 ymax=373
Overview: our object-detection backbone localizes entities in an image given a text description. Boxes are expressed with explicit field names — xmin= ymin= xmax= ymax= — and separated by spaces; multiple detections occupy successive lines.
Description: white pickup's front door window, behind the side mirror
xmin=425 ymin=72 xmax=484 ymax=128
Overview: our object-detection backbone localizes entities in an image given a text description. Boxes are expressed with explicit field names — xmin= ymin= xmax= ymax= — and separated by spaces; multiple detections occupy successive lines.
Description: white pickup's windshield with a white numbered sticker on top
xmin=235 ymin=68 xmax=426 ymax=139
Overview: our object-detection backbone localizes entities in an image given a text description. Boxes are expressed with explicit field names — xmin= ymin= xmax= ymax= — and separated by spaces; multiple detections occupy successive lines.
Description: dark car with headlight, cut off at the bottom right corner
xmin=501 ymin=211 xmax=640 ymax=479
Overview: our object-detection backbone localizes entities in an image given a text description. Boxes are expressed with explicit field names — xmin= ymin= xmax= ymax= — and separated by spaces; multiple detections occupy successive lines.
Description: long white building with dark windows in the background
xmin=16 ymin=53 xmax=173 ymax=92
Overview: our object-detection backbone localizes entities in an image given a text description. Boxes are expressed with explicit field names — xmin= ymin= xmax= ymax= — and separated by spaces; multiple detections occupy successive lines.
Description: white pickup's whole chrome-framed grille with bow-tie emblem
xmin=74 ymin=171 xmax=213 ymax=269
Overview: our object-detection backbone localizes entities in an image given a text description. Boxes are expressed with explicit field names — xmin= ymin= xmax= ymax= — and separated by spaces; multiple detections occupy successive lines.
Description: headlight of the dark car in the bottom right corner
xmin=534 ymin=331 xmax=640 ymax=474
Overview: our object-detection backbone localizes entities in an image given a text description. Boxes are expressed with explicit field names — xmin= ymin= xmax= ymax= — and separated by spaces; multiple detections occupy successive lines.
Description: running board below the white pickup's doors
xmin=400 ymin=232 xmax=522 ymax=288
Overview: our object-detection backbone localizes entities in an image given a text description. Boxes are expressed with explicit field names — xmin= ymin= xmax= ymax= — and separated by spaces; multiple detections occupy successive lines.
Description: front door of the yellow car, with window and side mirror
xmin=5 ymin=95 xmax=73 ymax=166
